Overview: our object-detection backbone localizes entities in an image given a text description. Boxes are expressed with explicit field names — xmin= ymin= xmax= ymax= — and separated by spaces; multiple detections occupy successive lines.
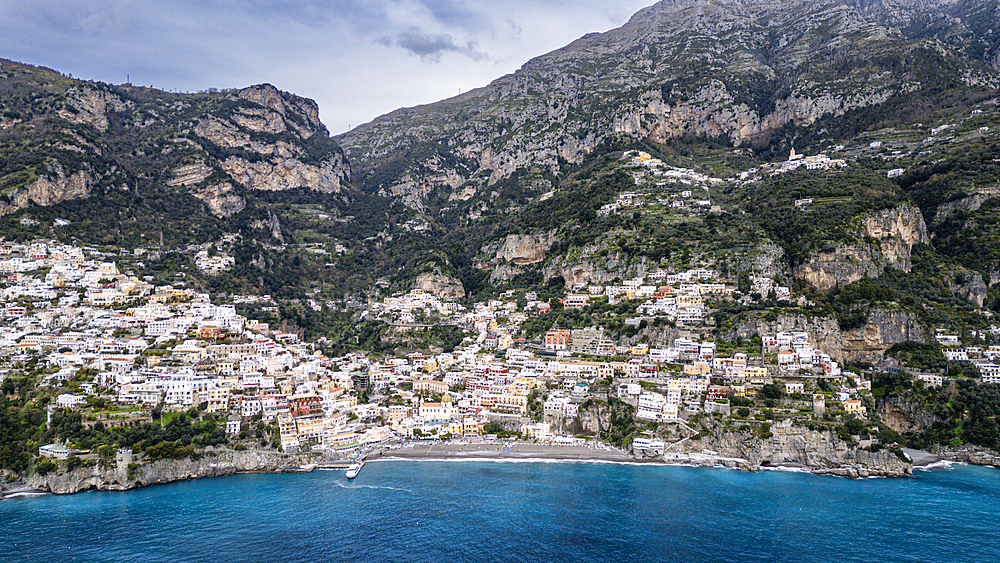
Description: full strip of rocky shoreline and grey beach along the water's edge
xmin=0 ymin=440 xmax=1000 ymax=498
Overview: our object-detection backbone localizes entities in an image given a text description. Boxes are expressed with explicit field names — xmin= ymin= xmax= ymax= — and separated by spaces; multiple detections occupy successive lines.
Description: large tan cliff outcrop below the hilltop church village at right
xmin=794 ymin=205 xmax=930 ymax=290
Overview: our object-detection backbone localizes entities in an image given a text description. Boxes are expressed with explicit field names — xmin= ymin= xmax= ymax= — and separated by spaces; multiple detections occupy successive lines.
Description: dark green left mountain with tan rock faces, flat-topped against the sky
xmin=0 ymin=61 xmax=350 ymax=244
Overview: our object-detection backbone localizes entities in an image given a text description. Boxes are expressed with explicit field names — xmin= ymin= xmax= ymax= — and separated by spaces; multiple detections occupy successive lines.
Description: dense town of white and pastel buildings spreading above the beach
xmin=7 ymin=241 xmax=1000 ymax=468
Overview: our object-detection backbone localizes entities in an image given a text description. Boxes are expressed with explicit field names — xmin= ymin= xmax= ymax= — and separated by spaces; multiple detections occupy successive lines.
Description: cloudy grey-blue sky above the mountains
xmin=0 ymin=0 xmax=654 ymax=134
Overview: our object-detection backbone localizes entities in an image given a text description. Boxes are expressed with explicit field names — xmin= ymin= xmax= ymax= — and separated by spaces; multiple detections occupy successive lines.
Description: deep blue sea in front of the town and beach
xmin=0 ymin=461 xmax=1000 ymax=563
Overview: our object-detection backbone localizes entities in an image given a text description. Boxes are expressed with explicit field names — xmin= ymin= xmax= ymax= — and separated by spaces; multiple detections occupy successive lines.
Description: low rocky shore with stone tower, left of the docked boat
xmin=0 ymin=449 xmax=320 ymax=496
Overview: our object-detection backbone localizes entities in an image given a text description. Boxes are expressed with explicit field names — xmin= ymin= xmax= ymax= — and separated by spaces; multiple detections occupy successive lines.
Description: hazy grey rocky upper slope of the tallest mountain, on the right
xmin=337 ymin=0 xmax=1000 ymax=214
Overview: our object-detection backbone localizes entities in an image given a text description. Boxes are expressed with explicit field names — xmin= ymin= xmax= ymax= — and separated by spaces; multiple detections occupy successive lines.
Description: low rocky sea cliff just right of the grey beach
xmin=664 ymin=426 xmax=913 ymax=479
